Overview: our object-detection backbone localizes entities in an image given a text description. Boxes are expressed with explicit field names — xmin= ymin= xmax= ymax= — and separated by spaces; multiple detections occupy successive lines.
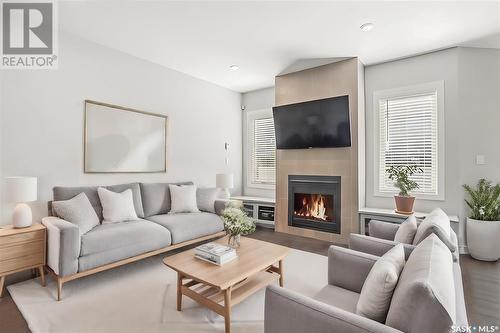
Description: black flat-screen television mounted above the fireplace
xmin=273 ymin=95 xmax=351 ymax=149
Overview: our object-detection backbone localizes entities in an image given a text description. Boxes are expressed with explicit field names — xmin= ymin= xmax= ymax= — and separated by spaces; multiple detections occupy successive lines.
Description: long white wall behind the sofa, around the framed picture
xmin=0 ymin=34 xmax=242 ymax=223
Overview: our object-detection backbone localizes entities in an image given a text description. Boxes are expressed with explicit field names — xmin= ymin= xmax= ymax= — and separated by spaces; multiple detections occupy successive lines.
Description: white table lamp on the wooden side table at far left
xmin=5 ymin=177 xmax=37 ymax=228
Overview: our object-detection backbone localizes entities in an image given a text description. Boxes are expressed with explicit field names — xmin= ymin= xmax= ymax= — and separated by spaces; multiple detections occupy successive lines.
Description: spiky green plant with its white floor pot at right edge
xmin=463 ymin=179 xmax=500 ymax=261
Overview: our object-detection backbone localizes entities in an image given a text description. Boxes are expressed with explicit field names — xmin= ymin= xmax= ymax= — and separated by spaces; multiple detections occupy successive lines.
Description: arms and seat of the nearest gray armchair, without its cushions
xmin=264 ymin=246 xmax=401 ymax=333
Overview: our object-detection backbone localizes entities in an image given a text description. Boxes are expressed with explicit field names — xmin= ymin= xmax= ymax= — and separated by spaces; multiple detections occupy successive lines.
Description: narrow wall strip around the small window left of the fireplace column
xmin=242 ymin=87 xmax=276 ymax=198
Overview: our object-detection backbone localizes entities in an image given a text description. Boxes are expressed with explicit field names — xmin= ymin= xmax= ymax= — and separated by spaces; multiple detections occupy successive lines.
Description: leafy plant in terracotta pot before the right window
xmin=386 ymin=165 xmax=424 ymax=215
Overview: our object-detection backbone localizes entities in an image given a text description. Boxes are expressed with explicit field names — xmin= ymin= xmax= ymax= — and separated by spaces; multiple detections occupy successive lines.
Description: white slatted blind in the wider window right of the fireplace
xmin=378 ymin=91 xmax=439 ymax=196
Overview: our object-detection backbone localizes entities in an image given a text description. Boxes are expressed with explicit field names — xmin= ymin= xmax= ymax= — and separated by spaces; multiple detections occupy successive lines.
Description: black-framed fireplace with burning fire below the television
xmin=288 ymin=175 xmax=340 ymax=234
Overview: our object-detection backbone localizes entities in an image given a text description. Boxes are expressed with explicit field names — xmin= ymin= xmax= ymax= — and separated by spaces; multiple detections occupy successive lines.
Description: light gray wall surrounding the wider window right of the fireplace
xmin=365 ymin=48 xmax=500 ymax=249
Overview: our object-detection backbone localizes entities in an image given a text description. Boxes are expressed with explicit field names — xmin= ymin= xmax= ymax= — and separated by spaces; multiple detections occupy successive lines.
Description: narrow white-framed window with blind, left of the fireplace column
xmin=247 ymin=110 xmax=276 ymax=188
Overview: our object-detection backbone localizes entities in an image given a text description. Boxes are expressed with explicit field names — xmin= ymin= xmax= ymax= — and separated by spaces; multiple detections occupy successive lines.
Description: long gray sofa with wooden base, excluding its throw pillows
xmin=42 ymin=182 xmax=228 ymax=299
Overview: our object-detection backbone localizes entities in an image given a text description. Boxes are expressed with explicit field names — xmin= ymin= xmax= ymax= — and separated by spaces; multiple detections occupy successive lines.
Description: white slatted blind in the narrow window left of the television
xmin=250 ymin=117 xmax=276 ymax=185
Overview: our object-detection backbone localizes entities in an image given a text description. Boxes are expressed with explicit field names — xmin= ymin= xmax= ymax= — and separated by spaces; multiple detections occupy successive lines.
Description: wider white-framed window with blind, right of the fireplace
xmin=374 ymin=82 xmax=444 ymax=200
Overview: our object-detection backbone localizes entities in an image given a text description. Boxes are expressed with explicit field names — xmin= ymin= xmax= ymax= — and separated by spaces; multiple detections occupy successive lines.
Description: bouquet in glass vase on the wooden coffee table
xmin=221 ymin=206 xmax=255 ymax=248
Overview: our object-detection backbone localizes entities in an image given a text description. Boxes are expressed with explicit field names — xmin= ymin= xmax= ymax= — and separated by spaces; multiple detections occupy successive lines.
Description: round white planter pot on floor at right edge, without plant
xmin=467 ymin=218 xmax=500 ymax=261
